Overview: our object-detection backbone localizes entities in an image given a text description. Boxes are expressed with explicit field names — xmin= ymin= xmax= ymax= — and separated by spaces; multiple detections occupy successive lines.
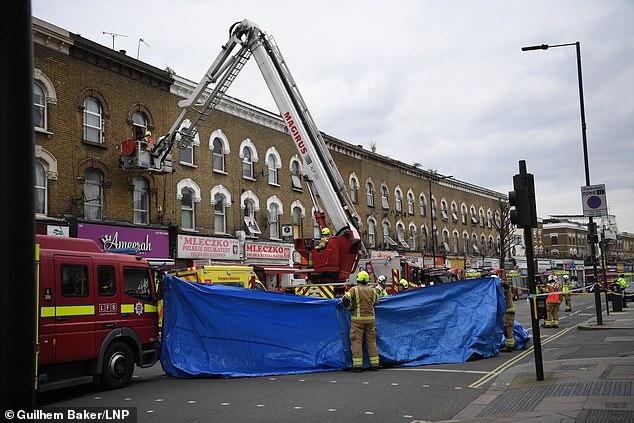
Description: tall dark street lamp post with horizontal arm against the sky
xmin=522 ymin=41 xmax=603 ymax=325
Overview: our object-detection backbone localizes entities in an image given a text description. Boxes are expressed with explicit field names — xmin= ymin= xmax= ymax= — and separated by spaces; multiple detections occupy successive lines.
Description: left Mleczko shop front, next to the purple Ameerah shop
xmin=176 ymin=234 xmax=242 ymax=268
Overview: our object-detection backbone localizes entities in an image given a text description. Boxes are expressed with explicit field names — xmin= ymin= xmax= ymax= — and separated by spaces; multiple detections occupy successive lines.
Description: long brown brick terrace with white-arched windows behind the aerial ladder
xmin=33 ymin=18 xmax=505 ymax=280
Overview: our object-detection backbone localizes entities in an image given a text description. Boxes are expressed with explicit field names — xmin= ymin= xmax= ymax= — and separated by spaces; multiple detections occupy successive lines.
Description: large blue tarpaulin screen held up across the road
xmin=161 ymin=276 xmax=520 ymax=377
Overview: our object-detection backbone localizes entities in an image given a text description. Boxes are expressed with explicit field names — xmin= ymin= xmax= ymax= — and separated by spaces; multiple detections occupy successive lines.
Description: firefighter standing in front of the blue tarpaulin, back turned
xmin=341 ymin=270 xmax=379 ymax=373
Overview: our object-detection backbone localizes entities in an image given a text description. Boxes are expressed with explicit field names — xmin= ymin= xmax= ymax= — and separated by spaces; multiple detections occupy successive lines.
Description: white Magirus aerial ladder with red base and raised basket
xmin=120 ymin=19 xmax=365 ymax=283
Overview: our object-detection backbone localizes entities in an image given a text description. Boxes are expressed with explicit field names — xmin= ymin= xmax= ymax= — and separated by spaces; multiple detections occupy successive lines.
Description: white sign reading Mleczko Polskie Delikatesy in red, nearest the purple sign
xmin=178 ymin=235 xmax=240 ymax=260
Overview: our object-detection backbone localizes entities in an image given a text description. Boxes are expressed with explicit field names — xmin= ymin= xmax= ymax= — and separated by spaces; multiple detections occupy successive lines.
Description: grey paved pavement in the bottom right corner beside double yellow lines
xmin=448 ymin=305 xmax=634 ymax=423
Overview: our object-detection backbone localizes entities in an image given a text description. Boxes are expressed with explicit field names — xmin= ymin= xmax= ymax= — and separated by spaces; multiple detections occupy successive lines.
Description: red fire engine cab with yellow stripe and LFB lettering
xmin=36 ymin=235 xmax=159 ymax=391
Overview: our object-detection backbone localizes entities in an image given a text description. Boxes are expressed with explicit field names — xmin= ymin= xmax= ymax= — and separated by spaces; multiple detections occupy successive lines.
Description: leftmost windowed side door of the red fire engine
xmin=54 ymin=255 xmax=96 ymax=363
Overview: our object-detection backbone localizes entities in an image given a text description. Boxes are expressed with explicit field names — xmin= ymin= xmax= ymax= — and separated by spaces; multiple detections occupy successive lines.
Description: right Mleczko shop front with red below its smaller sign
xmin=244 ymin=241 xmax=298 ymax=291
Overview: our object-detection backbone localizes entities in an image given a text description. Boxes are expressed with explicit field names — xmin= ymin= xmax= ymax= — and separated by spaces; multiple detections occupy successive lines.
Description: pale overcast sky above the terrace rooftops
xmin=33 ymin=0 xmax=634 ymax=232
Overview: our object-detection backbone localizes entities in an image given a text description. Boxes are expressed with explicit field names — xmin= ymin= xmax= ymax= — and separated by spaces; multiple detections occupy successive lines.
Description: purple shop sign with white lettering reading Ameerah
xmin=77 ymin=223 xmax=170 ymax=258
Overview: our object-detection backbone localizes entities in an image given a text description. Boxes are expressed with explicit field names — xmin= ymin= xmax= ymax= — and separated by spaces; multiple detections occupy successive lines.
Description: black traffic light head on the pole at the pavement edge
xmin=509 ymin=160 xmax=537 ymax=228
